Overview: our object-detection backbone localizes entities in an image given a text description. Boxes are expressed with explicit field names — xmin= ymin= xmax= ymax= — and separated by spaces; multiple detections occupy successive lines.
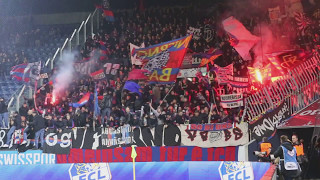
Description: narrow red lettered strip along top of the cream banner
xmin=188 ymin=123 xmax=233 ymax=131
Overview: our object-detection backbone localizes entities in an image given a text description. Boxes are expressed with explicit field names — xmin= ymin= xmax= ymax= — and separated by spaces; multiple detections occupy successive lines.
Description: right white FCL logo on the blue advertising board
xmin=219 ymin=162 xmax=254 ymax=180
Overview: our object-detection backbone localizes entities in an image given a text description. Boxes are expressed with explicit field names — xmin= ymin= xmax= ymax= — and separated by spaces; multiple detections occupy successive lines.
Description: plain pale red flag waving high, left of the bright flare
xmin=222 ymin=16 xmax=259 ymax=60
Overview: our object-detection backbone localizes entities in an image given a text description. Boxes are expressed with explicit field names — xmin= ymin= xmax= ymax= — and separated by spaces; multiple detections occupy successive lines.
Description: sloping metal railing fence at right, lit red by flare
xmin=244 ymin=53 xmax=320 ymax=121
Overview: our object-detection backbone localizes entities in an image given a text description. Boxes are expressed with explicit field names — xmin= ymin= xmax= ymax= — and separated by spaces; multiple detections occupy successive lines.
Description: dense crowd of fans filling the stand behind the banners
xmin=0 ymin=0 xmax=319 ymax=150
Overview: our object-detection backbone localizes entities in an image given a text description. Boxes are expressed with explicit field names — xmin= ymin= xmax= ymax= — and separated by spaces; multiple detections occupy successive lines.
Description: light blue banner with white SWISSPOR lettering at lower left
xmin=0 ymin=150 xmax=56 ymax=165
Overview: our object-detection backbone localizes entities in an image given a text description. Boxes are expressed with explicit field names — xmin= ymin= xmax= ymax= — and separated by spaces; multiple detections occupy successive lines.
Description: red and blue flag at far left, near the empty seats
xmin=10 ymin=62 xmax=41 ymax=82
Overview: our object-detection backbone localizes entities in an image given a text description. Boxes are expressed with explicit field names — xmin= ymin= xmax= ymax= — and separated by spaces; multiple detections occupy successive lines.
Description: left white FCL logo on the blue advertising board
xmin=69 ymin=163 xmax=112 ymax=180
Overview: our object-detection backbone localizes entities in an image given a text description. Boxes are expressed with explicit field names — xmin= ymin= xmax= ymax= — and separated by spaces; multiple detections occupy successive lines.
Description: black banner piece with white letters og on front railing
xmin=43 ymin=129 xmax=72 ymax=154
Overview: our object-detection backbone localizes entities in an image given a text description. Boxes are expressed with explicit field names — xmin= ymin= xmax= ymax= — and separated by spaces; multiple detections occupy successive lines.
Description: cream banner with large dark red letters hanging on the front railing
xmin=179 ymin=123 xmax=249 ymax=147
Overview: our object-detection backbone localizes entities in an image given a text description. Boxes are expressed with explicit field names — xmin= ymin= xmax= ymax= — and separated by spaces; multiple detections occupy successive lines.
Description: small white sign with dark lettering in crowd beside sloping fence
xmin=220 ymin=94 xmax=243 ymax=108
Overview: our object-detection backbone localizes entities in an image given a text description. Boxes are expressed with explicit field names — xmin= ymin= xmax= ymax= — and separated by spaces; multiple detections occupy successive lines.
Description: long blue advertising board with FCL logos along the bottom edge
xmin=0 ymin=161 xmax=271 ymax=180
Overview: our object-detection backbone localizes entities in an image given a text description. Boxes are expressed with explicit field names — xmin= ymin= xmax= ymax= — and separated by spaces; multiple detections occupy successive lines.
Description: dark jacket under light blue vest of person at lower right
xmin=274 ymin=142 xmax=300 ymax=177
